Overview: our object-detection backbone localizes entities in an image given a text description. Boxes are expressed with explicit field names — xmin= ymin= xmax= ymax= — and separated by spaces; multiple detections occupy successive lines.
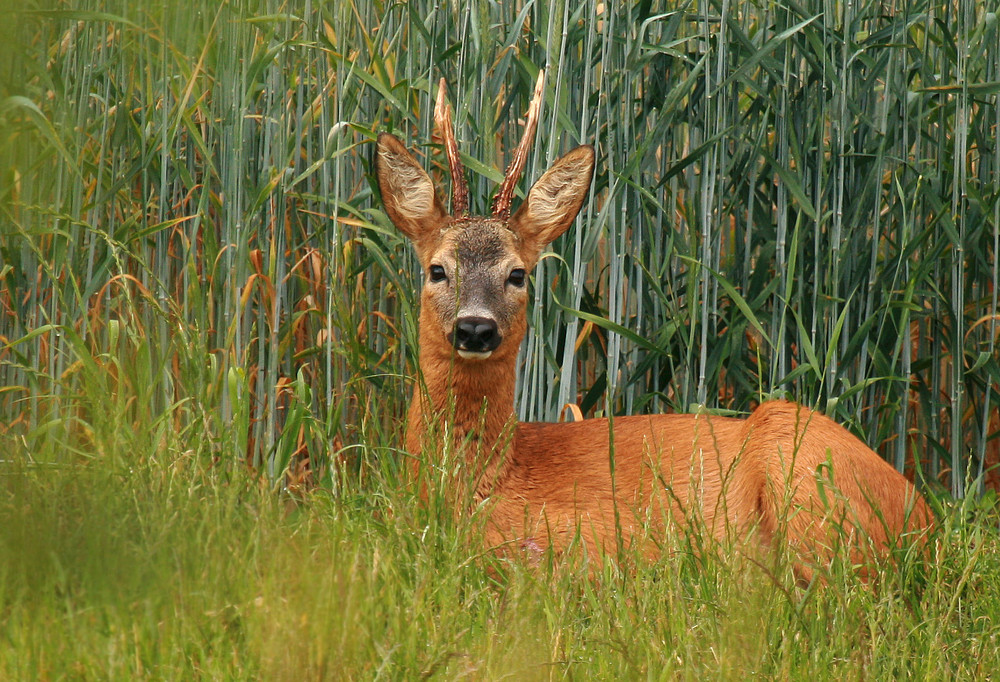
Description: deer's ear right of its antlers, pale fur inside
xmin=510 ymin=145 xmax=594 ymax=261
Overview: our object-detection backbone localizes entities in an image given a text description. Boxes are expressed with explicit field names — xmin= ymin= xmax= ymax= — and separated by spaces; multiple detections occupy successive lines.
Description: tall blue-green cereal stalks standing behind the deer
xmin=0 ymin=0 xmax=1000 ymax=496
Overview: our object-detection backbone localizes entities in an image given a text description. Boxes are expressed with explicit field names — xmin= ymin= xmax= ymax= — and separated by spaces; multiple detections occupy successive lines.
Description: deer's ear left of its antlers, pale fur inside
xmin=375 ymin=133 xmax=448 ymax=242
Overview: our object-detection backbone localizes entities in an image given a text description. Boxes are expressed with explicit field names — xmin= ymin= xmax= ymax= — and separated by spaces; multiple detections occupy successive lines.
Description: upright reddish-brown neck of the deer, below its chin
xmin=406 ymin=306 xmax=519 ymax=473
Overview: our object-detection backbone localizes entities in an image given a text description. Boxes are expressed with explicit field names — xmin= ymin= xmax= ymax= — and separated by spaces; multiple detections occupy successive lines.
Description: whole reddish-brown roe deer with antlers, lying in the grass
xmin=376 ymin=75 xmax=933 ymax=579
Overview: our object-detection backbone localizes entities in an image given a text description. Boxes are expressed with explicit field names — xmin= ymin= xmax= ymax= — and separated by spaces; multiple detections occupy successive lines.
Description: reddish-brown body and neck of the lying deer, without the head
xmin=407 ymin=318 xmax=931 ymax=564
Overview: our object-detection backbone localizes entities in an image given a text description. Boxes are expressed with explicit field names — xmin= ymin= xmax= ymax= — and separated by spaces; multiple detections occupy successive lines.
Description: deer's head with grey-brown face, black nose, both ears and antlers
xmin=376 ymin=73 xmax=594 ymax=362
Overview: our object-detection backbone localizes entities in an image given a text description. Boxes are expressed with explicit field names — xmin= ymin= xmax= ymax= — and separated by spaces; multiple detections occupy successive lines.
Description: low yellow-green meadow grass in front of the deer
xmin=0 ymin=430 xmax=1000 ymax=680
